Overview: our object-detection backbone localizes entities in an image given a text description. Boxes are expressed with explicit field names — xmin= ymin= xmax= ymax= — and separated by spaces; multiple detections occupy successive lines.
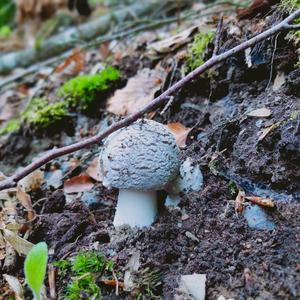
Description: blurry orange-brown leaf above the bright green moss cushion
xmin=54 ymin=48 xmax=85 ymax=77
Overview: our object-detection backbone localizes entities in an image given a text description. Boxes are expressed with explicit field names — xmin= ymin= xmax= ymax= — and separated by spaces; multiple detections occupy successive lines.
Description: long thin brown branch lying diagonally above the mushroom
xmin=0 ymin=9 xmax=300 ymax=191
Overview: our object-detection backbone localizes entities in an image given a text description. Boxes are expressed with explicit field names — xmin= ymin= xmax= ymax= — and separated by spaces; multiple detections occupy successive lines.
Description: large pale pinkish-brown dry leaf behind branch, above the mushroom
xmin=107 ymin=68 xmax=166 ymax=115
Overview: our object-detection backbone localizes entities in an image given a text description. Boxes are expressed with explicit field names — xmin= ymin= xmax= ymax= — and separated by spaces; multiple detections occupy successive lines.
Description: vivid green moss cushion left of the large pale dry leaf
xmin=58 ymin=67 xmax=120 ymax=110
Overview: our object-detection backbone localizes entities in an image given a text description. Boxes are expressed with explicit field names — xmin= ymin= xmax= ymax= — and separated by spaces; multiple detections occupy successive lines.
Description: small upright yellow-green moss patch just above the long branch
xmin=186 ymin=32 xmax=214 ymax=71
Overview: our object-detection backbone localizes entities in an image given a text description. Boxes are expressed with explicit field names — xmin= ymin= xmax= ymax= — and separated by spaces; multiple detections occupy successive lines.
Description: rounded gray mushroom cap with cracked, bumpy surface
xmin=100 ymin=119 xmax=180 ymax=190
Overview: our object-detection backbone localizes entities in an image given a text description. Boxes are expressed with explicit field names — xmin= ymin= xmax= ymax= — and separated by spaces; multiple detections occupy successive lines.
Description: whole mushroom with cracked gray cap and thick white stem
xmin=99 ymin=119 xmax=180 ymax=228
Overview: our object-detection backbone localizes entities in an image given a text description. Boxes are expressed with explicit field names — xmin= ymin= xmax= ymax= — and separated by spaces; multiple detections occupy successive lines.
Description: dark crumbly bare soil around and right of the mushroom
xmin=0 ymin=9 xmax=300 ymax=300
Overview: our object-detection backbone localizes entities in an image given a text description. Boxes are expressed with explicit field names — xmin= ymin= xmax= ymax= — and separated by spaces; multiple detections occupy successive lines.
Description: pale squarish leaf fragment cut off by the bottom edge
xmin=179 ymin=274 xmax=206 ymax=300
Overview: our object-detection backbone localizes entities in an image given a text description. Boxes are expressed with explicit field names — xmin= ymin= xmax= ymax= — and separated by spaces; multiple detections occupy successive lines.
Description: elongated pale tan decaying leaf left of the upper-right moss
xmin=148 ymin=26 xmax=198 ymax=55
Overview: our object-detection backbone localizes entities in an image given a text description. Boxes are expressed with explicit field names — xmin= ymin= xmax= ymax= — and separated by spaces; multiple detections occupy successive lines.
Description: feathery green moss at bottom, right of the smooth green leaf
xmin=54 ymin=251 xmax=114 ymax=300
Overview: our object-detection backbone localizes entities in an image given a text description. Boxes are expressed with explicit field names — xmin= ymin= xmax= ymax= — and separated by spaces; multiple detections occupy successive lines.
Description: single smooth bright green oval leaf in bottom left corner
xmin=24 ymin=242 xmax=48 ymax=300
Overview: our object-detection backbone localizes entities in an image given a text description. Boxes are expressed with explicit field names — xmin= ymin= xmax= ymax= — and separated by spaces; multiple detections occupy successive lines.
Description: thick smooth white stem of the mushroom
xmin=114 ymin=189 xmax=157 ymax=228
